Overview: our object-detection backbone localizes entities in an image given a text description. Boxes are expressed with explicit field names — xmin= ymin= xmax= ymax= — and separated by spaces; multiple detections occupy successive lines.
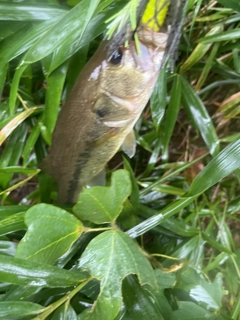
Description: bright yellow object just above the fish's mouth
xmin=142 ymin=0 xmax=170 ymax=31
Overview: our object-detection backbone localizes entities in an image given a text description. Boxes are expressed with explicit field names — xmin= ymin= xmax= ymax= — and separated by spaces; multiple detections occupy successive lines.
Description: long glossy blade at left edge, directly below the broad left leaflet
xmin=0 ymin=255 xmax=87 ymax=288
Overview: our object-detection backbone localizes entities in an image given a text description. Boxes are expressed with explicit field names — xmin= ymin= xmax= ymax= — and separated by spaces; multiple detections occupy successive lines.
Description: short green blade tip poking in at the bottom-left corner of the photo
xmin=0 ymin=301 xmax=45 ymax=320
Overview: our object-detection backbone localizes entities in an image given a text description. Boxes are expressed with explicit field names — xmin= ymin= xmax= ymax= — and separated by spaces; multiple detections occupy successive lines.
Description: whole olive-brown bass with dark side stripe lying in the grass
xmin=41 ymin=0 xmax=178 ymax=204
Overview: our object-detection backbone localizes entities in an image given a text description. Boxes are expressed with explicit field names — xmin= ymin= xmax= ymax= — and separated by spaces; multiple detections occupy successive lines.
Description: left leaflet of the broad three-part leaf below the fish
xmin=16 ymin=204 xmax=83 ymax=264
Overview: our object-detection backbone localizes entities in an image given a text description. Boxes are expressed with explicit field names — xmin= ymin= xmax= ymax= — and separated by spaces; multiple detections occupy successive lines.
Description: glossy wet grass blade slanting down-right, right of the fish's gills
xmin=181 ymin=77 xmax=219 ymax=155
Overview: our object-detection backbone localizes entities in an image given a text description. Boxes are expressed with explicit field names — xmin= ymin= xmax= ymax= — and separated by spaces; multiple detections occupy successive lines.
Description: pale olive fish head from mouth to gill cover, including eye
xmin=86 ymin=27 xmax=168 ymax=126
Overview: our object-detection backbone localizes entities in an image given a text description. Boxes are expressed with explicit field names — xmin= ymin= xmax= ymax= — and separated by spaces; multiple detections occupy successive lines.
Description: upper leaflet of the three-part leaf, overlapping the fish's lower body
xmin=73 ymin=170 xmax=131 ymax=224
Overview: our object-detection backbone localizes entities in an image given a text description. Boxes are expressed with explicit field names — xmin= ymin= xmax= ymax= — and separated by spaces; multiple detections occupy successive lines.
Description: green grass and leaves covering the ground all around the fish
xmin=0 ymin=0 xmax=240 ymax=320
